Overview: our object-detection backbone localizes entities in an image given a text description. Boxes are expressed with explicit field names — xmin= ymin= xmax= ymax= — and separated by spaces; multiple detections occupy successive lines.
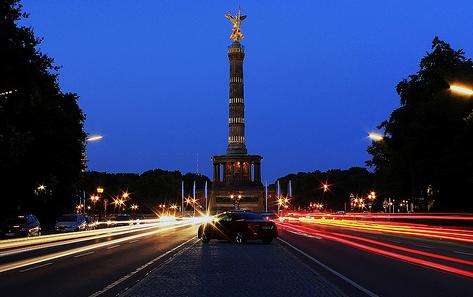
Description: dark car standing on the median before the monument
xmin=197 ymin=211 xmax=278 ymax=244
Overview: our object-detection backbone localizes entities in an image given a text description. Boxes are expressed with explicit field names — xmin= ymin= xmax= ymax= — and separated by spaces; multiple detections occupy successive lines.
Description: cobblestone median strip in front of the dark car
xmin=121 ymin=240 xmax=344 ymax=297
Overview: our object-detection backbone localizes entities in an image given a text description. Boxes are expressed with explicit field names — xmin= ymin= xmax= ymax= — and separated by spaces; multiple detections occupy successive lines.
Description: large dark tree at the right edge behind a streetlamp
xmin=368 ymin=37 xmax=473 ymax=211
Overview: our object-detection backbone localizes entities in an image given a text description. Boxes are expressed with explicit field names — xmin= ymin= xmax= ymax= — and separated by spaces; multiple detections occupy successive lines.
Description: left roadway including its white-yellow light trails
xmin=0 ymin=222 xmax=196 ymax=296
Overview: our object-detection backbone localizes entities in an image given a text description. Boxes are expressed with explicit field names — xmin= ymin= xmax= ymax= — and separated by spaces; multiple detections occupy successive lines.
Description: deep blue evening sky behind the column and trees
xmin=24 ymin=0 xmax=473 ymax=181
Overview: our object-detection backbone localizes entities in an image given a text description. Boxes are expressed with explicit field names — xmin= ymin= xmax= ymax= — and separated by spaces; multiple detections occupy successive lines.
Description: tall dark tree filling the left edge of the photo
xmin=0 ymin=0 xmax=85 ymax=219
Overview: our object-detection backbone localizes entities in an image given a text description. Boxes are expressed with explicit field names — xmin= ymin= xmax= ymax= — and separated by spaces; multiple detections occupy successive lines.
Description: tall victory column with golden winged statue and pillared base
xmin=209 ymin=10 xmax=264 ymax=211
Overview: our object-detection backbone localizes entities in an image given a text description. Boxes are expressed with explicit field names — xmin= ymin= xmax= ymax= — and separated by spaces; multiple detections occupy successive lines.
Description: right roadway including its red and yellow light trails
xmin=278 ymin=215 xmax=473 ymax=296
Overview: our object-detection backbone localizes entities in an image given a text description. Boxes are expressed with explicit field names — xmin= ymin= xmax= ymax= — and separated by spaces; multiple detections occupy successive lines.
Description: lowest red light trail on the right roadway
xmin=277 ymin=223 xmax=473 ymax=278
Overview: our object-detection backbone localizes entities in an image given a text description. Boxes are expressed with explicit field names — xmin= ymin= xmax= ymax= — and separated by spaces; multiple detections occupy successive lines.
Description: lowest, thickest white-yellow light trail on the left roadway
xmin=0 ymin=220 xmax=200 ymax=273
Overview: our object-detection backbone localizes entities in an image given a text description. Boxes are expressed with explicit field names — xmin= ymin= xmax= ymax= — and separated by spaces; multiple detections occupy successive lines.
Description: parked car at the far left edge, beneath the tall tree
xmin=1 ymin=214 xmax=41 ymax=238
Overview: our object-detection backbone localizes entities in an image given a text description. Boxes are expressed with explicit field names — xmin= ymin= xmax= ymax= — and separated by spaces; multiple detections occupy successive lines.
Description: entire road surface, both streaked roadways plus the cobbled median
xmin=0 ymin=217 xmax=473 ymax=297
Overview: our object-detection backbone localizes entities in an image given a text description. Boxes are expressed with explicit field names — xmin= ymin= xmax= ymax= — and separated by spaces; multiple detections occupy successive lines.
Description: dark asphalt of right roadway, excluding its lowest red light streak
xmin=280 ymin=224 xmax=473 ymax=297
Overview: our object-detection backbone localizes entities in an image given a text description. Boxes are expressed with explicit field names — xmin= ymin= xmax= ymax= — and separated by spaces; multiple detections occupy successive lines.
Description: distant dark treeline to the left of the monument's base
xmin=82 ymin=169 xmax=211 ymax=213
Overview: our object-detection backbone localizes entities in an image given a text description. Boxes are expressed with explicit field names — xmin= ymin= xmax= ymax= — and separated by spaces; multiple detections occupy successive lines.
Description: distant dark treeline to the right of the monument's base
xmin=271 ymin=167 xmax=375 ymax=210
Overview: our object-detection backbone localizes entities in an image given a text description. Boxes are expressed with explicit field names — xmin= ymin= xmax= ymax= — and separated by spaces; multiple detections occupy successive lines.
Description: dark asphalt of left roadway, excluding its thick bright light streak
xmin=0 ymin=222 xmax=196 ymax=297
